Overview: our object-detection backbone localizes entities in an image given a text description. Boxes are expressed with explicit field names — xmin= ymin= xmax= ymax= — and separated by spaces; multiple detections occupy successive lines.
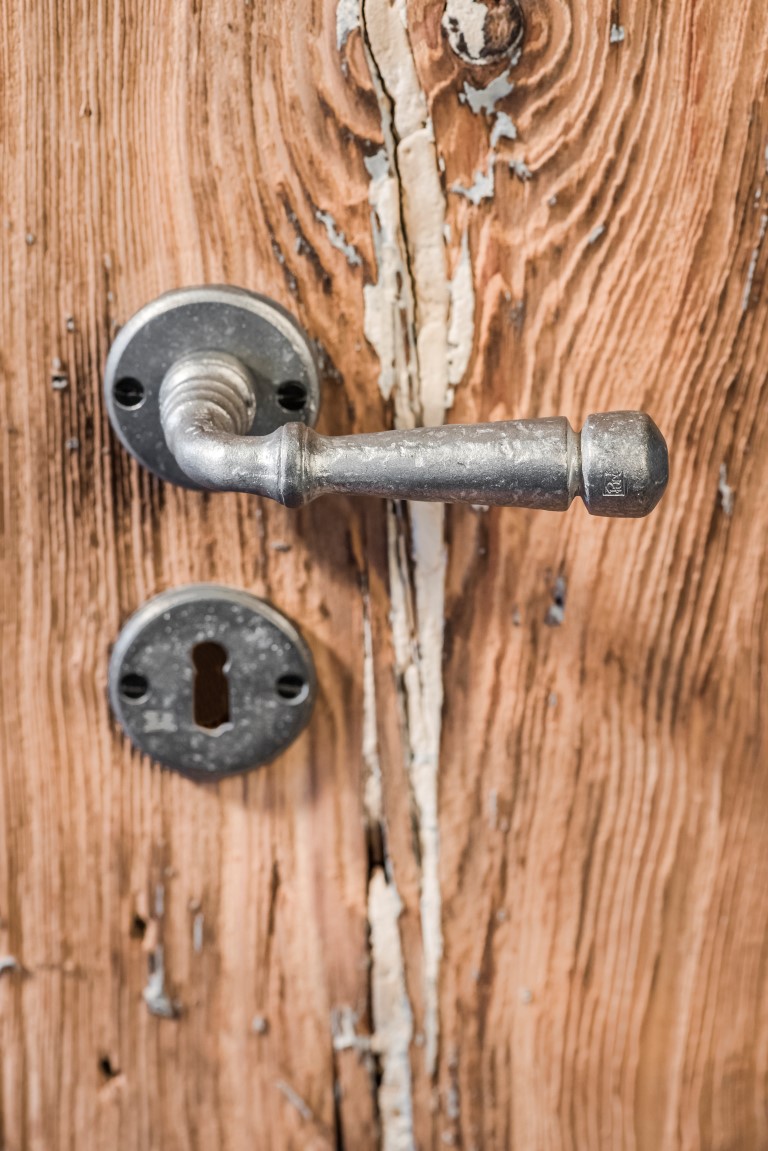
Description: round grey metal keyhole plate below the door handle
xmin=109 ymin=584 xmax=315 ymax=779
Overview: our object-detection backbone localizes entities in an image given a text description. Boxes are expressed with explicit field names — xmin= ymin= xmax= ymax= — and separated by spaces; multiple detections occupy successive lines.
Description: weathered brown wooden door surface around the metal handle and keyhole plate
xmin=0 ymin=0 xmax=768 ymax=1151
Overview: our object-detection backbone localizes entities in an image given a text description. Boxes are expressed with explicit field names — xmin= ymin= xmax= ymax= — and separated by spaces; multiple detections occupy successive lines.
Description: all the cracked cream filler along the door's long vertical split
xmin=363 ymin=0 xmax=474 ymax=1086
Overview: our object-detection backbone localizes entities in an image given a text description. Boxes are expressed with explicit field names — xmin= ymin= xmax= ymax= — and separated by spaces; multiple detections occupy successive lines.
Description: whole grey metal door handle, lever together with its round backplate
xmin=106 ymin=288 xmax=669 ymax=517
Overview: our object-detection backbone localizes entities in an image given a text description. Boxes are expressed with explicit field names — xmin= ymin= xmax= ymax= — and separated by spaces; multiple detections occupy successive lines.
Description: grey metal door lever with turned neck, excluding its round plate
xmin=101 ymin=289 xmax=669 ymax=517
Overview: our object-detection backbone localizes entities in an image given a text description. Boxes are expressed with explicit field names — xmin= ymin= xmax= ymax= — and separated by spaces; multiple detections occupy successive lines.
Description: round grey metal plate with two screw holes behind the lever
xmin=104 ymin=287 xmax=320 ymax=488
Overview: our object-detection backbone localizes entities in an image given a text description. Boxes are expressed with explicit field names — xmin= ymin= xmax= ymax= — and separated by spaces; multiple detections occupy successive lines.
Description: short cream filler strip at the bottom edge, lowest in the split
xmin=368 ymin=868 xmax=416 ymax=1151
